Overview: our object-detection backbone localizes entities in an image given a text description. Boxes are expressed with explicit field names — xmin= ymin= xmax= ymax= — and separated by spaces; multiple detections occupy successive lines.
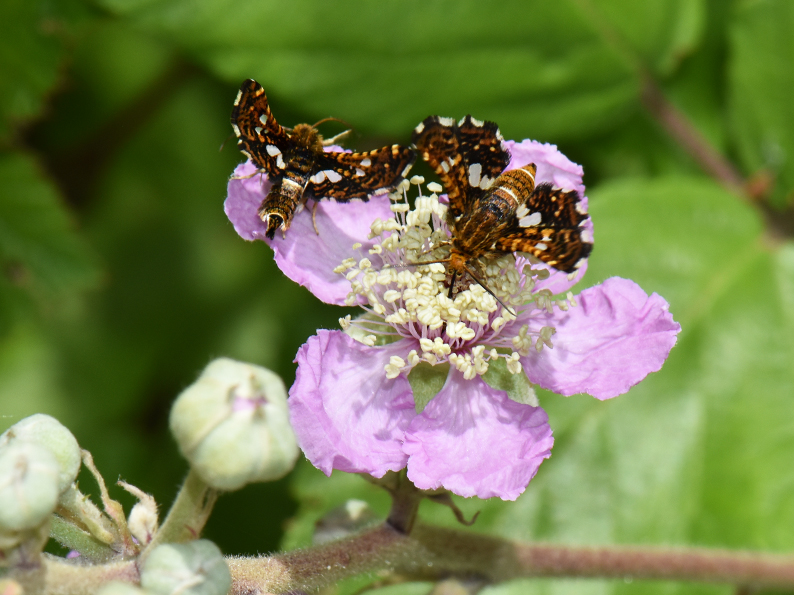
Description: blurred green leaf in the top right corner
xmin=729 ymin=0 xmax=794 ymax=204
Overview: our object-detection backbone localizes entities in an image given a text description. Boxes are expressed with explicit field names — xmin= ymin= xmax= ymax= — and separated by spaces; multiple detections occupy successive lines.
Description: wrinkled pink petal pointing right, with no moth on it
xmin=522 ymin=277 xmax=681 ymax=400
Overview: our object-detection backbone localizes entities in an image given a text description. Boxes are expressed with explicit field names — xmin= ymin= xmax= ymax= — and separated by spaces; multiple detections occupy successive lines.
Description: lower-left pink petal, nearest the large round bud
xmin=288 ymin=330 xmax=416 ymax=477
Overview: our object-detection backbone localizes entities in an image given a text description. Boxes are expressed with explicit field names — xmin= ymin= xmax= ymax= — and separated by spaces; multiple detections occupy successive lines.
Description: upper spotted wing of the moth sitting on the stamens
xmin=412 ymin=116 xmax=510 ymax=221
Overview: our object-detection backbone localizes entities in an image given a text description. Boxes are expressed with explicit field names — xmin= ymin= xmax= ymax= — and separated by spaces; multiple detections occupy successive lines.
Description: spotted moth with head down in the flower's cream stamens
xmin=412 ymin=116 xmax=593 ymax=297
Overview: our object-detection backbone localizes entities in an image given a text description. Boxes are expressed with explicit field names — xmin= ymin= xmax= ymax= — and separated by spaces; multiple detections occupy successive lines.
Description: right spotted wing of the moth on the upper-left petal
xmin=309 ymin=145 xmax=416 ymax=202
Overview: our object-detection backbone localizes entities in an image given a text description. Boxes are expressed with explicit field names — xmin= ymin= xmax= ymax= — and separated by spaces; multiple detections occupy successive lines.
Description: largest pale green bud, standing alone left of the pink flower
xmin=170 ymin=358 xmax=299 ymax=490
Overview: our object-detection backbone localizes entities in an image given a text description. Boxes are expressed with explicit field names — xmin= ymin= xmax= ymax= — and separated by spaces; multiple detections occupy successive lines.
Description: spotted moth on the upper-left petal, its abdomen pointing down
xmin=231 ymin=79 xmax=416 ymax=239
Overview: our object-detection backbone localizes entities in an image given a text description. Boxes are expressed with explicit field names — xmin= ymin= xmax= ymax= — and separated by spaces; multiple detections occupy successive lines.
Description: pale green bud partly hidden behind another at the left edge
xmin=0 ymin=413 xmax=82 ymax=494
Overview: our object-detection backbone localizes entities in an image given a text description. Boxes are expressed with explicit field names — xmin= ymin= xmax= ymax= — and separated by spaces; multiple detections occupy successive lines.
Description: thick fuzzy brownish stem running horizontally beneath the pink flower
xmin=224 ymin=525 xmax=794 ymax=594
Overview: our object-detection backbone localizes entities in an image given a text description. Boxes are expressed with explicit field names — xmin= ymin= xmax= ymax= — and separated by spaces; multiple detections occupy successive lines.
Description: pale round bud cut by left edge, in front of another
xmin=0 ymin=440 xmax=59 ymax=532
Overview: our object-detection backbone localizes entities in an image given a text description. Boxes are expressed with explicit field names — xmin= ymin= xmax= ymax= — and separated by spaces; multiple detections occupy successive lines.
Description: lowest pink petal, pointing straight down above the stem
xmin=403 ymin=368 xmax=554 ymax=500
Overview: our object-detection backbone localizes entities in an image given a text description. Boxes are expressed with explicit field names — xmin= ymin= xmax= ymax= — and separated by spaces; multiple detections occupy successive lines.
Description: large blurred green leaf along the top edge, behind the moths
xmin=91 ymin=0 xmax=702 ymax=142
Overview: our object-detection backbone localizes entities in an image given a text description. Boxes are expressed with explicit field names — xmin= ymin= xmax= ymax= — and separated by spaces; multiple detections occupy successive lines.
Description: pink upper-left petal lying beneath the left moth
xmin=224 ymin=156 xmax=393 ymax=306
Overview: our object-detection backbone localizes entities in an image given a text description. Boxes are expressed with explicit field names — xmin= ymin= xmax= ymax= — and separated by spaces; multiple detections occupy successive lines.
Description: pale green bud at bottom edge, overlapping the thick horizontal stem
xmin=141 ymin=539 xmax=232 ymax=595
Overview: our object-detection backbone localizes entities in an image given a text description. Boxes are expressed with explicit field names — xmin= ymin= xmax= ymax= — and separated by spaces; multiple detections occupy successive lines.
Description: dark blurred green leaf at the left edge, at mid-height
xmin=0 ymin=153 xmax=99 ymax=305
